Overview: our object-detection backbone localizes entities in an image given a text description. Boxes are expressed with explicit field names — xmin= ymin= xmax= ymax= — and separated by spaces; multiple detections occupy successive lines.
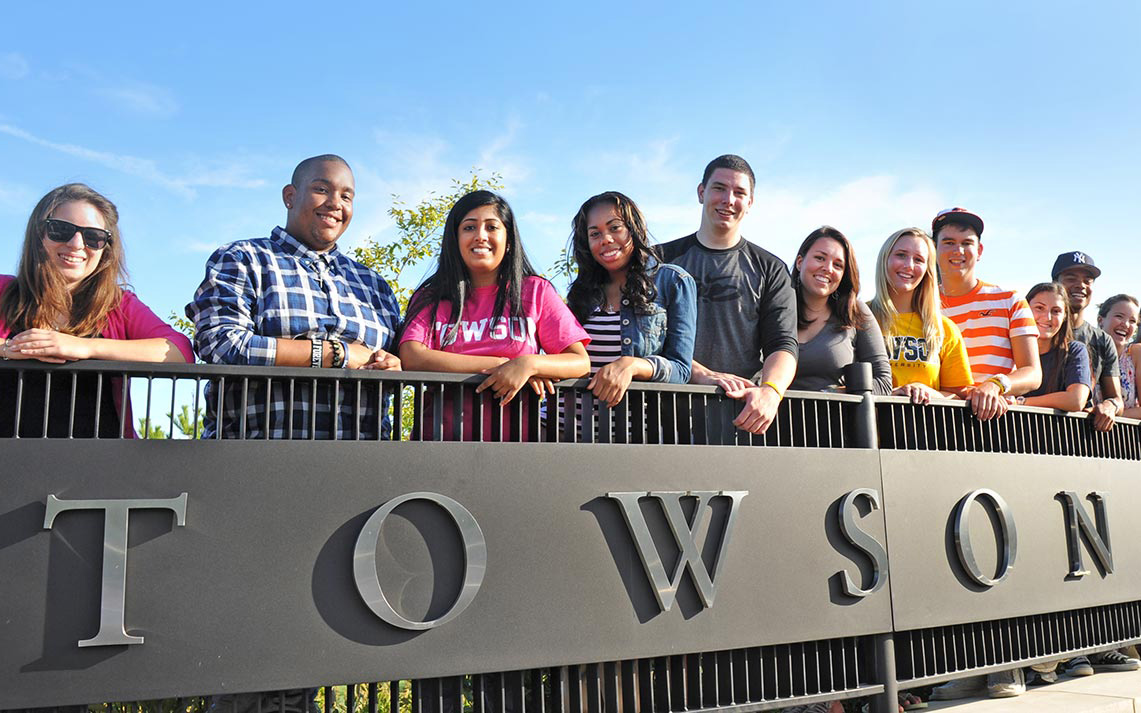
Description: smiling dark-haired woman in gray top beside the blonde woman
xmin=790 ymin=226 xmax=891 ymax=395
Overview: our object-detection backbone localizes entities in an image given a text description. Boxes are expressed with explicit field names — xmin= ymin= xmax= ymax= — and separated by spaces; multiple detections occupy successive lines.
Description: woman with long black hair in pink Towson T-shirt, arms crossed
xmin=398 ymin=191 xmax=590 ymax=438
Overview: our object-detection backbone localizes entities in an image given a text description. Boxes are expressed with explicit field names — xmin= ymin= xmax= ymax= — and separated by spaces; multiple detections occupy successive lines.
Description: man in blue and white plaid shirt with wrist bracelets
xmin=186 ymin=154 xmax=400 ymax=438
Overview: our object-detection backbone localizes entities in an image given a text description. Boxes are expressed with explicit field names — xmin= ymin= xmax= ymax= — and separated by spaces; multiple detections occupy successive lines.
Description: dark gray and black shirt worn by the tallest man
xmin=658 ymin=233 xmax=798 ymax=379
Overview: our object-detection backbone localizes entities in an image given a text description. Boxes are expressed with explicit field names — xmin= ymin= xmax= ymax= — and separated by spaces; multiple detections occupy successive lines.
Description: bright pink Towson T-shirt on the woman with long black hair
xmin=400 ymin=277 xmax=590 ymax=440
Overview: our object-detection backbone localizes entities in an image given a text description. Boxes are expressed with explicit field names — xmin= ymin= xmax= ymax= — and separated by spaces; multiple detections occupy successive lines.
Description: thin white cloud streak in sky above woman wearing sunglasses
xmin=0 ymin=124 xmax=265 ymax=198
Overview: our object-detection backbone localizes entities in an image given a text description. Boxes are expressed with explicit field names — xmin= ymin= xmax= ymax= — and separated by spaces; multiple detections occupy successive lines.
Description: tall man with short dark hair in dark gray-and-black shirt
xmin=661 ymin=154 xmax=798 ymax=434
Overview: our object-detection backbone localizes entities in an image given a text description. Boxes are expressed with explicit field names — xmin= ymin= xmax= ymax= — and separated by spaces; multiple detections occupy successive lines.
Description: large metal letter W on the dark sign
xmin=606 ymin=491 xmax=748 ymax=611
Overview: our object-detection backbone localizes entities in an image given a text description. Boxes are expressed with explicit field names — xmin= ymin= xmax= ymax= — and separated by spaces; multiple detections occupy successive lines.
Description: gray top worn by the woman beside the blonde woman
xmin=788 ymin=302 xmax=891 ymax=395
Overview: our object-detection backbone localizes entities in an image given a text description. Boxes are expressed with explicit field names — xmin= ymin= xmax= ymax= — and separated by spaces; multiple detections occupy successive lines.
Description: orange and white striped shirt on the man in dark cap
xmin=940 ymin=281 xmax=1038 ymax=383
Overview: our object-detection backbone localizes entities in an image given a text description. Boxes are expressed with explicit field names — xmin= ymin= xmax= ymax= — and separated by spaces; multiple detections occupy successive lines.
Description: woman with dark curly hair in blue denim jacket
xmin=567 ymin=191 xmax=697 ymax=406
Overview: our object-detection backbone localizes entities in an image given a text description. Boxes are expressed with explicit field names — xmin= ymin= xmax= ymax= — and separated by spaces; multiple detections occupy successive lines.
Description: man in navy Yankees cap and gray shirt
xmin=1050 ymin=250 xmax=1125 ymax=431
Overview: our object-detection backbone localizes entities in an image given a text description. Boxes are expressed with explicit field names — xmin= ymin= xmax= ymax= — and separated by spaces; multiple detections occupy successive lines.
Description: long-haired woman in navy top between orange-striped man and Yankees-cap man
xmin=1012 ymin=282 xmax=1091 ymax=411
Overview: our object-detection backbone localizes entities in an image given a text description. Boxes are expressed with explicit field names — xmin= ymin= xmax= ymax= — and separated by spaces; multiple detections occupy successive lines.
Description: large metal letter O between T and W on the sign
xmin=353 ymin=493 xmax=487 ymax=631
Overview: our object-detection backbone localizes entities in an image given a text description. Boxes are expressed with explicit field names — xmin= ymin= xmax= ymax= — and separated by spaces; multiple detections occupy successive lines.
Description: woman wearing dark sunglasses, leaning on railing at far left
xmin=0 ymin=184 xmax=194 ymax=437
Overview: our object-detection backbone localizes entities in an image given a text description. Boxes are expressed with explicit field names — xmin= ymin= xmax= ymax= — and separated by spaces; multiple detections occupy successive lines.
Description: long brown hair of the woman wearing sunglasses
xmin=0 ymin=184 xmax=127 ymax=337
